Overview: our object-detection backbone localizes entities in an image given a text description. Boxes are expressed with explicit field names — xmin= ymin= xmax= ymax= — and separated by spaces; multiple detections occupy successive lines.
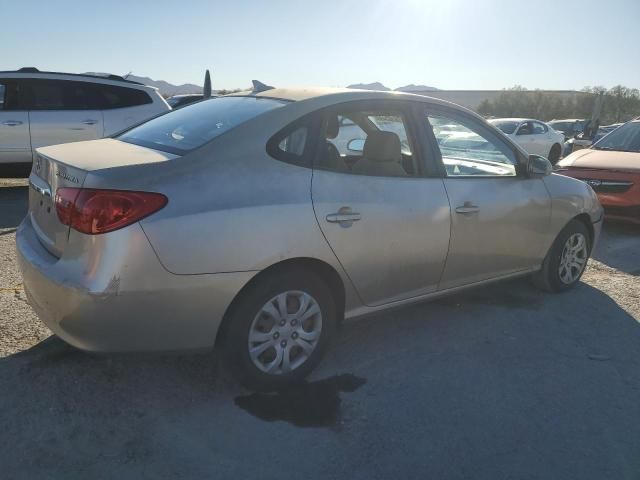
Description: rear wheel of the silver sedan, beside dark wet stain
xmin=224 ymin=269 xmax=336 ymax=390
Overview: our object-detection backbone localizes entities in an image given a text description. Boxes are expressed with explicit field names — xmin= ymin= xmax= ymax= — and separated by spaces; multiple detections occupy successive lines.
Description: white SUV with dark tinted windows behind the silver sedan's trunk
xmin=0 ymin=67 xmax=171 ymax=168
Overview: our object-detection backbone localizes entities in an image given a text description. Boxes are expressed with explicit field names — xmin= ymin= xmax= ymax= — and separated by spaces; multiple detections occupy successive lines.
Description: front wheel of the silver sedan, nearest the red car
xmin=534 ymin=220 xmax=591 ymax=292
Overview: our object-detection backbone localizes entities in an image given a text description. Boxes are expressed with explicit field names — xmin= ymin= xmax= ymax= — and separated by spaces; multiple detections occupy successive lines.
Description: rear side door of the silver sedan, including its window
xmin=312 ymin=101 xmax=450 ymax=306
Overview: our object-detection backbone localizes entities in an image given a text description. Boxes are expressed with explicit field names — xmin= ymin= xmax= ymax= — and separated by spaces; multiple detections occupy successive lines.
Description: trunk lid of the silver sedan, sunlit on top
xmin=29 ymin=139 xmax=175 ymax=257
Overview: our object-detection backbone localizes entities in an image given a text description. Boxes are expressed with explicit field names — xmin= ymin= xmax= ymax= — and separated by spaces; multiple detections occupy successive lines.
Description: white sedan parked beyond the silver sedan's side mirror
xmin=489 ymin=118 xmax=564 ymax=165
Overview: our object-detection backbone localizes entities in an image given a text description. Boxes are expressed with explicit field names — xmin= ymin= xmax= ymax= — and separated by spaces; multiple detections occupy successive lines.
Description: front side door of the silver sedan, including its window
xmin=424 ymin=107 xmax=551 ymax=289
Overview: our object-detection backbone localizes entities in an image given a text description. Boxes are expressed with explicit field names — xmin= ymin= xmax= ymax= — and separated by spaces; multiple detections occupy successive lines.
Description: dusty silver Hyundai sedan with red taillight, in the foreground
xmin=17 ymin=84 xmax=602 ymax=388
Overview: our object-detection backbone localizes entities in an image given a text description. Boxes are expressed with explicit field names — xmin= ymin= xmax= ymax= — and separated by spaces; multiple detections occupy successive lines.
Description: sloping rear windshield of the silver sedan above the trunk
xmin=118 ymin=97 xmax=287 ymax=155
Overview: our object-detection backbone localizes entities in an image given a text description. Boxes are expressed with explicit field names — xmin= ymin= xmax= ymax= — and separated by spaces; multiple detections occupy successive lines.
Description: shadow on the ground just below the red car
xmin=592 ymin=221 xmax=640 ymax=275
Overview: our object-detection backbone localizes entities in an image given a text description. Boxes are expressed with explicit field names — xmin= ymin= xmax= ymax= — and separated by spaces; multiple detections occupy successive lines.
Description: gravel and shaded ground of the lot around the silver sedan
xmin=0 ymin=179 xmax=640 ymax=480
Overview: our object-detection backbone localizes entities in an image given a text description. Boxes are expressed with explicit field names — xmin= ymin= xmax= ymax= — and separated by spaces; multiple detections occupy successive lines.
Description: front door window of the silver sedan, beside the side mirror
xmin=427 ymin=113 xmax=517 ymax=177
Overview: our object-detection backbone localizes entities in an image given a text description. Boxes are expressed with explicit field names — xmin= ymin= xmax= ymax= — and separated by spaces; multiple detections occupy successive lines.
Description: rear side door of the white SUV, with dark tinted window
xmin=24 ymin=79 xmax=103 ymax=149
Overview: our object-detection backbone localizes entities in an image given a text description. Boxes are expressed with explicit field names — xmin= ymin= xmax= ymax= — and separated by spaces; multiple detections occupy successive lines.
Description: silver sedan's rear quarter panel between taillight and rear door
xmin=123 ymin=110 xmax=340 ymax=280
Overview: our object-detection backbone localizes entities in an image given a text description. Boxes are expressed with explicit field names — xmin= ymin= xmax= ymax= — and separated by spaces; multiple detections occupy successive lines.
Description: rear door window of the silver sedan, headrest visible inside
xmin=314 ymin=109 xmax=417 ymax=177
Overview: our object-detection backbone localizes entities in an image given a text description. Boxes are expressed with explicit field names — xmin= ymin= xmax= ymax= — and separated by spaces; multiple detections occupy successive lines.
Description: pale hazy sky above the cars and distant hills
xmin=0 ymin=0 xmax=640 ymax=89
